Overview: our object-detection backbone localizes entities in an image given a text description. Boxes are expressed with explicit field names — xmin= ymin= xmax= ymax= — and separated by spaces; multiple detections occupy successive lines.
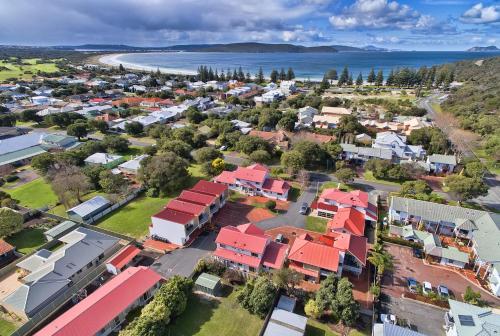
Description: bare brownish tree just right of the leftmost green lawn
xmin=48 ymin=165 xmax=90 ymax=208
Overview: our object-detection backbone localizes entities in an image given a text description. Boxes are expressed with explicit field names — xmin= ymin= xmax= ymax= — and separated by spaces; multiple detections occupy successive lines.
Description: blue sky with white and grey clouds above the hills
xmin=0 ymin=0 xmax=500 ymax=50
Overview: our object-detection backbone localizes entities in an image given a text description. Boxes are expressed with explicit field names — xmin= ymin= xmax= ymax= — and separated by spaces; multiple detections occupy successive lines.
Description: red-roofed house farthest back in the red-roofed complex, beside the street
xmin=214 ymin=164 xmax=290 ymax=201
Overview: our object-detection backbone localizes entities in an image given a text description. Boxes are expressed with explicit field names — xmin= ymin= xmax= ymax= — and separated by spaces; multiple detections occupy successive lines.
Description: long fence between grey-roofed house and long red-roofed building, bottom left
xmin=11 ymin=244 xmax=122 ymax=336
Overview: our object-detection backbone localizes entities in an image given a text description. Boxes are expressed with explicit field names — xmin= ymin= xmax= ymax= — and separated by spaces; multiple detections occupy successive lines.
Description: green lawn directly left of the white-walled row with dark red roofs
xmin=97 ymin=196 xmax=170 ymax=238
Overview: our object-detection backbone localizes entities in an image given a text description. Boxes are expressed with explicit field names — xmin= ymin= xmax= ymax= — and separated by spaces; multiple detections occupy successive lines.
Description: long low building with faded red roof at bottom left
xmin=35 ymin=266 xmax=162 ymax=336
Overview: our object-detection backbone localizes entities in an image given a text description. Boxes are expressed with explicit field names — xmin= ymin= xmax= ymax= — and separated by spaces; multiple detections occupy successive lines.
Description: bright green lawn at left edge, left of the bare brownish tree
xmin=5 ymin=178 xmax=58 ymax=209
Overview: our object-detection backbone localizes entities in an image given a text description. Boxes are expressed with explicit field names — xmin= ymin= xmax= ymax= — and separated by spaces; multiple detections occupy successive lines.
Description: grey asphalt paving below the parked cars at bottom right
xmin=381 ymin=295 xmax=446 ymax=336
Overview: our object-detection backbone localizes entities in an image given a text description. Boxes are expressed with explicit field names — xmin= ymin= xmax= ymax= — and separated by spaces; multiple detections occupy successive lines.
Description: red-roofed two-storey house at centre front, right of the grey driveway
xmin=213 ymin=223 xmax=288 ymax=273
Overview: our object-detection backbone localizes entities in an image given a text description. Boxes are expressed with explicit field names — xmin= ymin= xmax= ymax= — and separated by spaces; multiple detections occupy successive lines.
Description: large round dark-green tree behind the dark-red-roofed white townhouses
xmin=138 ymin=152 xmax=189 ymax=195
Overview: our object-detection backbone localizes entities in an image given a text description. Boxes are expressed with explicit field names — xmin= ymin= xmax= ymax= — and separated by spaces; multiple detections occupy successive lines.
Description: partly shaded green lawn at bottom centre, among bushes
xmin=167 ymin=291 xmax=264 ymax=336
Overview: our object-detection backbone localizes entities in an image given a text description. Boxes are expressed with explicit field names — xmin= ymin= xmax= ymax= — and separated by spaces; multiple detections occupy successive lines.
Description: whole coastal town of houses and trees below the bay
xmin=0 ymin=43 xmax=500 ymax=336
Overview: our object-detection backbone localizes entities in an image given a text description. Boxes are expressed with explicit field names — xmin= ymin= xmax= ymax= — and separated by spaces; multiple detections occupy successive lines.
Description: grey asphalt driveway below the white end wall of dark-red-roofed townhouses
xmin=151 ymin=232 xmax=216 ymax=279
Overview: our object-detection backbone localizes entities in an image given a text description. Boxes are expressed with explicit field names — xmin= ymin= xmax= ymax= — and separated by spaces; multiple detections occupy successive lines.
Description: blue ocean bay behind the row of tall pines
xmin=110 ymin=51 xmax=500 ymax=80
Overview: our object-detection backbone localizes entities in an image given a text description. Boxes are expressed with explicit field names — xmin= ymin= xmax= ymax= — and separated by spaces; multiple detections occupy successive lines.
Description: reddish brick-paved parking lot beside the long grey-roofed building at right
xmin=382 ymin=244 xmax=500 ymax=306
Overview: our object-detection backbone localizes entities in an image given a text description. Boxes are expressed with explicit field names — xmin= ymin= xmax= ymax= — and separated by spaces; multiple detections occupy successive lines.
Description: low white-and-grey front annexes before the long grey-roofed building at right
xmin=389 ymin=224 xmax=469 ymax=268
